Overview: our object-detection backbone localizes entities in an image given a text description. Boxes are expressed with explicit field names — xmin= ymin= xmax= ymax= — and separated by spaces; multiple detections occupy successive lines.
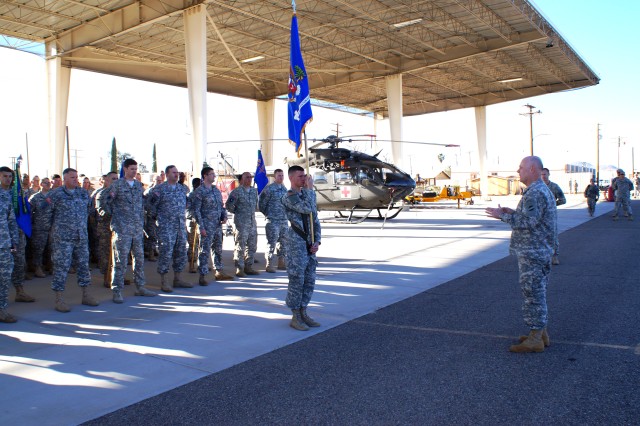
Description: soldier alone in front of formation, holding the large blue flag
xmin=282 ymin=166 xmax=321 ymax=331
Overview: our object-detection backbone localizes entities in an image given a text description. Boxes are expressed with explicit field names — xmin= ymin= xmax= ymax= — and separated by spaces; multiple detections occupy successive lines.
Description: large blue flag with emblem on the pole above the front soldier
xmin=288 ymin=1 xmax=313 ymax=156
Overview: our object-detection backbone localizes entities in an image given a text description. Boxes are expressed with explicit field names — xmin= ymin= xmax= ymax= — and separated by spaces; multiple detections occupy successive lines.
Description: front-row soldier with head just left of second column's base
xmin=147 ymin=166 xmax=193 ymax=293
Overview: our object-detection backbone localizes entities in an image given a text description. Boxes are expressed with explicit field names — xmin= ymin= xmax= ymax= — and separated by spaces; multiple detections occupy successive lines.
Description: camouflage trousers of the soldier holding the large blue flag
xmin=285 ymin=236 xmax=318 ymax=309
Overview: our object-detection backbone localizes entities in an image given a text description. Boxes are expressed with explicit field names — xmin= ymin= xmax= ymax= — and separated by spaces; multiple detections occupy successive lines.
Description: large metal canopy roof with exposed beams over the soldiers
xmin=0 ymin=0 xmax=599 ymax=116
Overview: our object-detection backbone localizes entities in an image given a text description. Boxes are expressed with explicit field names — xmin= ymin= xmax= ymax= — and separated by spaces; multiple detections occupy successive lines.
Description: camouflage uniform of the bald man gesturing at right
xmin=500 ymin=180 xmax=557 ymax=330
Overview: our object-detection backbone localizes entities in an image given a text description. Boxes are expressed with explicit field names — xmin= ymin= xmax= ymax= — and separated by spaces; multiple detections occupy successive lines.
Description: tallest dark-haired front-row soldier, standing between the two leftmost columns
xmin=97 ymin=158 xmax=156 ymax=303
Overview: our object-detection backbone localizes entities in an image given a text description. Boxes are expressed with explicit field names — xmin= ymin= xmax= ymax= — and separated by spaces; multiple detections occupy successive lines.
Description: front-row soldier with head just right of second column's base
xmin=191 ymin=167 xmax=232 ymax=285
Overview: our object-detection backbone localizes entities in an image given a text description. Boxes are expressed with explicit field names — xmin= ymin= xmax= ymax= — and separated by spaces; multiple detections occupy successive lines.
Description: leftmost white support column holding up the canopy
xmin=46 ymin=45 xmax=71 ymax=175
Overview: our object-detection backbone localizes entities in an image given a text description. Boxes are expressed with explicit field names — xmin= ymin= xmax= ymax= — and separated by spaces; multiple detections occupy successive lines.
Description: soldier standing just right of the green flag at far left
xmin=29 ymin=177 xmax=52 ymax=278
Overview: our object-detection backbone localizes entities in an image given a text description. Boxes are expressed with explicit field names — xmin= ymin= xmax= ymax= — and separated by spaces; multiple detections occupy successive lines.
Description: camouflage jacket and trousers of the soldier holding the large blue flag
xmin=281 ymin=188 xmax=321 ymax=309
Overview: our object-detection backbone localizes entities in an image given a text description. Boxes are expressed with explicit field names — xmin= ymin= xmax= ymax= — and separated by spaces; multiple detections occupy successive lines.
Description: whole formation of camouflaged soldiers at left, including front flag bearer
xmin=0 ymin=159 xmax=320 ymax=330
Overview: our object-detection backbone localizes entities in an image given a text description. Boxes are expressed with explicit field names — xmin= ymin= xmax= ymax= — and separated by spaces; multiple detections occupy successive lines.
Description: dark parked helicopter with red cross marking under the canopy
xmin=285 ymin=135 xmax=416 ymax=223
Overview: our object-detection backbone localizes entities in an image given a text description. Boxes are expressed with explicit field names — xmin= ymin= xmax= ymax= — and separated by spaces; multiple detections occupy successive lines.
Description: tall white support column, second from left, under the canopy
xmin=182 ymin=5 xmax=207 ymax=170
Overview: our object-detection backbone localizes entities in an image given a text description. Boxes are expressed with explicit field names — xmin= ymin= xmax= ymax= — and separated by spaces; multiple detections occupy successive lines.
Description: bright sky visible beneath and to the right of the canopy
xmin=0 ymin=0 xmax=640 ymax=181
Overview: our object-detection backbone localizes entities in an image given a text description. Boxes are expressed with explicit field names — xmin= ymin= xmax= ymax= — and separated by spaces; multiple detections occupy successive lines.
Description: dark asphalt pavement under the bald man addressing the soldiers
xmin=87 ymin=201 xmax=640 ymax=425
